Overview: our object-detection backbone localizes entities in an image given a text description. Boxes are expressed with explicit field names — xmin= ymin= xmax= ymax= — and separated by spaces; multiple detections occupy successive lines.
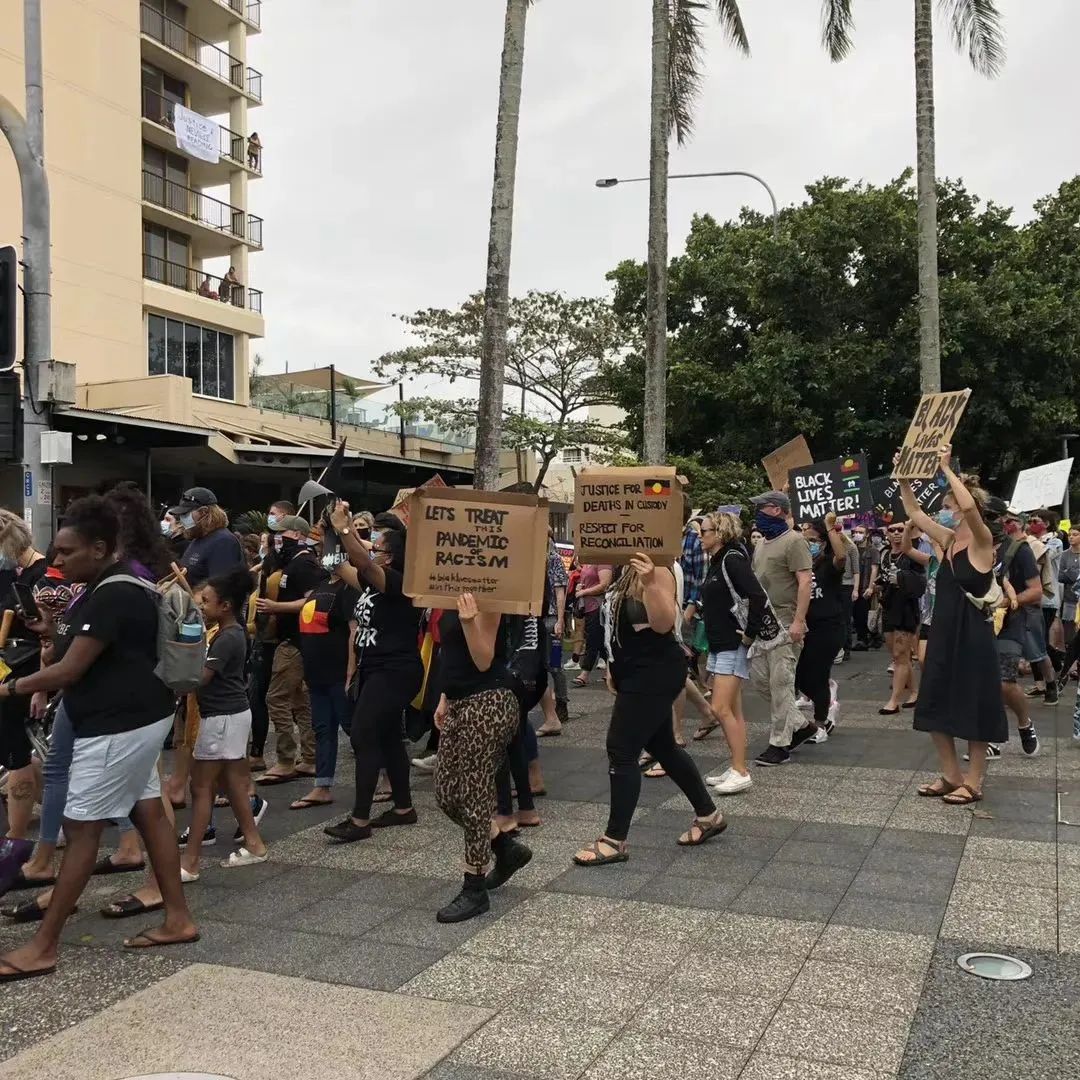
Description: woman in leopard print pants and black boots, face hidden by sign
xmin=435 ymin=593 xmax=532 ymax=922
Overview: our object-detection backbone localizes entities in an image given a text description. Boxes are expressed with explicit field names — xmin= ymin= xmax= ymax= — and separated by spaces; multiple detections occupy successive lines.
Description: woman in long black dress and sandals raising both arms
xmin=900 ymin=446 xmax=1009 ymax=806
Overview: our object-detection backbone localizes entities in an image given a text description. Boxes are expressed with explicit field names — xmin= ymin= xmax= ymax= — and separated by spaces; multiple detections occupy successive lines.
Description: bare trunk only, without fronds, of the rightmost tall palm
xmin=915 ymin=0 xmax=942 ymax=394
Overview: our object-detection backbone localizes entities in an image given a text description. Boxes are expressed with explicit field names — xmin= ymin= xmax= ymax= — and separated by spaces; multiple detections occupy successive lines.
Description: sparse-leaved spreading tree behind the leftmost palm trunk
xmin=375 ymin=292 xmax=637 ymax=490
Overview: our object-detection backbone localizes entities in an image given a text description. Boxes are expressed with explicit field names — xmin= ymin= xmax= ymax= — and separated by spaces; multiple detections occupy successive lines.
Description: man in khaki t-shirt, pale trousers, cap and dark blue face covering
xmin=750 ymin=491 xmax=818 ymax=766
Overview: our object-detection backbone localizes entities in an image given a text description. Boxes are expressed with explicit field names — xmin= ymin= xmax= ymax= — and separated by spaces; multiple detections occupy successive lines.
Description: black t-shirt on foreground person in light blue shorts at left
xmin=57 ymin=563 xmax=176 ymax=739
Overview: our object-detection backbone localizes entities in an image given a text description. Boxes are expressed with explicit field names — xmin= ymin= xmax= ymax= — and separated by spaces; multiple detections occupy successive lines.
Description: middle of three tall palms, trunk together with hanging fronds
xmin=643 ymin=0 xmax=750 ymax=464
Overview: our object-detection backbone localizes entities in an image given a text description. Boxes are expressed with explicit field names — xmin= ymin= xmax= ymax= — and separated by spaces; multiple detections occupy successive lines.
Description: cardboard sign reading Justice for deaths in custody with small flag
xmin=573 ymin=465 xmax=683 ymax=566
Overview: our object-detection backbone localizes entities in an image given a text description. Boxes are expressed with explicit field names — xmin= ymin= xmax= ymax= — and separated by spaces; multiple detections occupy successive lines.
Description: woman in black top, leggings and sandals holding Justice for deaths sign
xmin=573 ymin=552 xmax=727 ymax=866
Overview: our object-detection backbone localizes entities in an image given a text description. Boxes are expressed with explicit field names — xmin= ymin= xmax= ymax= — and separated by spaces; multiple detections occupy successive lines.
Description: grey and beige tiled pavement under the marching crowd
xmin=0 ymin=653 xmax=1080 ymax=1080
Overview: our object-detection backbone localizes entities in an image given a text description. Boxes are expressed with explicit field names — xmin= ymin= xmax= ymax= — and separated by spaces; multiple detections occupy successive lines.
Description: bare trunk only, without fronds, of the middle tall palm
xmin=644 ymin=0 xmax=671 ymax=465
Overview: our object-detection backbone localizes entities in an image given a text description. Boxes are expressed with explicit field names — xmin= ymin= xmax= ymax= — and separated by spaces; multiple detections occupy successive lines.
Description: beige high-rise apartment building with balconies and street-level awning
xmin=0 ymin=0 xmax=498 ymax=508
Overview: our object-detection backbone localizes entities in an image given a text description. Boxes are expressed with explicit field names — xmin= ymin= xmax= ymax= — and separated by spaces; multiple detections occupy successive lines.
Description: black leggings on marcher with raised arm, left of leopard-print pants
xmin=349 ymin=660 xmax=423 ymax=821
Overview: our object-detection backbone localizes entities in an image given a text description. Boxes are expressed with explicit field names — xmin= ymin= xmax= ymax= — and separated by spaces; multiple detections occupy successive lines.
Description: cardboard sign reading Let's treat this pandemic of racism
xmin=403 ymin=486 xmax=548 ymax=615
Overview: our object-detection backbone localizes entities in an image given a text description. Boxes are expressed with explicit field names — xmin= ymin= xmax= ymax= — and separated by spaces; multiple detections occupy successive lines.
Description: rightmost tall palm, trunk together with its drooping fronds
xmin=822 ymin=0 xmax=1004 ymax=394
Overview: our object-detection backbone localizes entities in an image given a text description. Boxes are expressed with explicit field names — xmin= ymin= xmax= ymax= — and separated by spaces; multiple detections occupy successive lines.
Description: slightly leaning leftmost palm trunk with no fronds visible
xmin=473 ymin=0 xmax=529 ymax=491
